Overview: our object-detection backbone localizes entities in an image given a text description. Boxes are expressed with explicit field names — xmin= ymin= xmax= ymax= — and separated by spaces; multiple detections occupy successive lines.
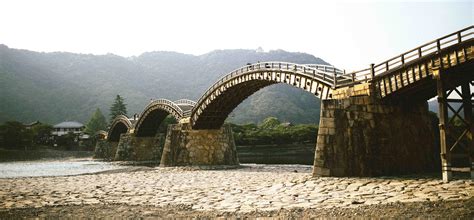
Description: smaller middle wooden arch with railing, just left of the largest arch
xmin=135 ymin=99 xmax=183 ymax=137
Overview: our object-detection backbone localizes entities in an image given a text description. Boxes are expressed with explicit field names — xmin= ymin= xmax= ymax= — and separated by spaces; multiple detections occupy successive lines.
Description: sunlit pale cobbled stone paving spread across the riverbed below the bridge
xmin=0 ymin=165 xmax=474 ymax=213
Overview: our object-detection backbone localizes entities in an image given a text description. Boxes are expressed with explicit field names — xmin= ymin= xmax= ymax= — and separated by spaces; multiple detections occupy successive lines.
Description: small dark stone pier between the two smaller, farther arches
xmin=115 ymin=134 xmax=164 ymax=162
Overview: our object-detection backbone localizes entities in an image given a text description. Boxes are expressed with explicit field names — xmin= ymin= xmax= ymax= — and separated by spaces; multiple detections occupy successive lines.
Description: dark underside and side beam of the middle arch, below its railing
xmin=135 ymin=106 xmax=181 ymax=137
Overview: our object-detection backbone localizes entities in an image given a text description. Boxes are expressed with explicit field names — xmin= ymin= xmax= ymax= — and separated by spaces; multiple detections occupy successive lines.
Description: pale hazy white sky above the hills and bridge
xmin=0 ymin=0 xmax=474 ymax=70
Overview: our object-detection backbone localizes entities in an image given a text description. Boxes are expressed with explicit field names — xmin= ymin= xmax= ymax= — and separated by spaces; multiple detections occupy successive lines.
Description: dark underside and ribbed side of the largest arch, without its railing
xmin=191 ymin=71 xmax=332 ymax=129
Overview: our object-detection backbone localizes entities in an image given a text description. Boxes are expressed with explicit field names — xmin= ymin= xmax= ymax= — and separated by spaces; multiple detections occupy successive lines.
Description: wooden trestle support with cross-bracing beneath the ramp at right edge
xmin=433 ymin=68 xmax=474 ymax=182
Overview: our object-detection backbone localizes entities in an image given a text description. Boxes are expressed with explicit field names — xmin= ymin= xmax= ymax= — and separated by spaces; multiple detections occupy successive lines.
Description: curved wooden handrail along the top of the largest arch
xmin=193 ymin=61 xmax=338 ymax=117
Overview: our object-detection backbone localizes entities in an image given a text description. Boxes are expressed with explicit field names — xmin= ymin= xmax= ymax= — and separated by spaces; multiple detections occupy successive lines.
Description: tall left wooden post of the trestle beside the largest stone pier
xmin=432 ymin=67 xmax=453 ymax=182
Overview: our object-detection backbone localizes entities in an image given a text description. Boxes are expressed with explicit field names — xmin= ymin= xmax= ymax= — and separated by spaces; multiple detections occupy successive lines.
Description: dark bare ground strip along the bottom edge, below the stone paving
xmin=0 ymin=198 xmax=474 ymax=219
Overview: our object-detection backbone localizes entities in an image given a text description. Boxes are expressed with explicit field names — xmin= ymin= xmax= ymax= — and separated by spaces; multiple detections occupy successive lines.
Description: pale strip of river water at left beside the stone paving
xmin=0 ymin=159 xmax=124 ymax=178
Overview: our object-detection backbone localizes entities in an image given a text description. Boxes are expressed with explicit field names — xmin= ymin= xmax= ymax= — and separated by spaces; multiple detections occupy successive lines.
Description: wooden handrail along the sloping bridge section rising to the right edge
xmin=346 ymin=25 xmax=474 ymax=87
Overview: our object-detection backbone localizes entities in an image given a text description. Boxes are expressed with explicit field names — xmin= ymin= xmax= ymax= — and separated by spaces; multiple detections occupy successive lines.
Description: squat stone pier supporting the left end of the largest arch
xmin=160 ymin=123 xmax=239 ymax=166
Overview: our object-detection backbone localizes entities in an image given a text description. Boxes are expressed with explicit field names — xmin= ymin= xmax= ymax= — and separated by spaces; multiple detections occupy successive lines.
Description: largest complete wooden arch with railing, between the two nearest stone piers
xmin=191 ymin=62 xmax=342 ymax=129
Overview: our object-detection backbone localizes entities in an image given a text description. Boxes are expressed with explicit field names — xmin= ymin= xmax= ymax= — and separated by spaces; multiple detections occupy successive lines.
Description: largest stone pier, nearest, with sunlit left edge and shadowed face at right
xmin=313 ymin=96 xmax=439 ymax=176
